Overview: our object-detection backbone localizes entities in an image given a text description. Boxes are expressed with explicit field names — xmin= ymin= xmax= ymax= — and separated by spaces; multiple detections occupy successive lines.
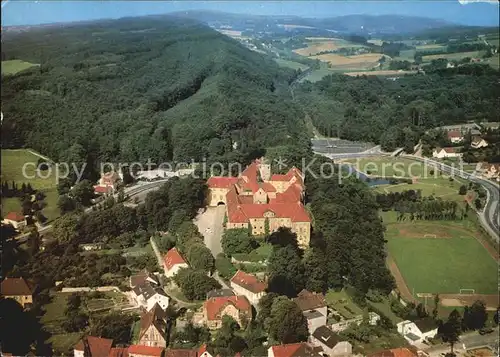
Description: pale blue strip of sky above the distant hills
xmin=1 ymin=0 xmax=499 ymax=26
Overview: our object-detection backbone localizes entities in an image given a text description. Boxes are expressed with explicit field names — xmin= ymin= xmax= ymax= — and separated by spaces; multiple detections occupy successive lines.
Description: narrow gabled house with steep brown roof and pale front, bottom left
xmin=138 ymin=304 xmax=167 ymax=347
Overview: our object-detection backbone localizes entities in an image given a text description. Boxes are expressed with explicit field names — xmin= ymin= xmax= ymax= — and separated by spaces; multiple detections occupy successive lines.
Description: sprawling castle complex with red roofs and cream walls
xmin=207 ymin=160 xmax=311 ymax=248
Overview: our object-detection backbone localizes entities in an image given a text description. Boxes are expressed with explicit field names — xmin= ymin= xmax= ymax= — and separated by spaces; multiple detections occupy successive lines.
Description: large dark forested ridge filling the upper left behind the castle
xmin=1 ymin=16 xmax=309 ymax=162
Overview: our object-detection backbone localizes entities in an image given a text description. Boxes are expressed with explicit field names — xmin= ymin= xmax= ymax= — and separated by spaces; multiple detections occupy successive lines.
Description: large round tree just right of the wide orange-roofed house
xmin=268 ymin=296 xmax=308 ymax=343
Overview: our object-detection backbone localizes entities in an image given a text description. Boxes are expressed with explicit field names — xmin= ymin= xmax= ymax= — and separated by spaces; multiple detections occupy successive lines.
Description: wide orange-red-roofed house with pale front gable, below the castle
xmin=203 ymin=296 xmax=252 ymax=329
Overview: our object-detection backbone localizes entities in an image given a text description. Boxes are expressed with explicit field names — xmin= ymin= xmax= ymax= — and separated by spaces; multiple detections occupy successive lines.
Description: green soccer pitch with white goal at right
xmin=383 ymin=220 xmax=498 ymax=294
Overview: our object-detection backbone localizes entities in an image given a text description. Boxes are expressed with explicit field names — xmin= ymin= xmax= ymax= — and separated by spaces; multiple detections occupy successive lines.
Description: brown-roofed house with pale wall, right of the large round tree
xmin=293 ymin=289 xmax=328 ymax=334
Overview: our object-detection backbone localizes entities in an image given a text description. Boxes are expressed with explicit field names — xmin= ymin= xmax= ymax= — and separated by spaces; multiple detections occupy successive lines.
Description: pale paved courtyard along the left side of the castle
xmin=194 ymin=205 xmax=226 ymax=258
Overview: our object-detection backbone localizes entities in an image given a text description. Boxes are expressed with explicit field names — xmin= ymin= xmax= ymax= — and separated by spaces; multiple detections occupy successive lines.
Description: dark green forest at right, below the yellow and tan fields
xmin=295 ymin=65 xmax=500 ymax=150
